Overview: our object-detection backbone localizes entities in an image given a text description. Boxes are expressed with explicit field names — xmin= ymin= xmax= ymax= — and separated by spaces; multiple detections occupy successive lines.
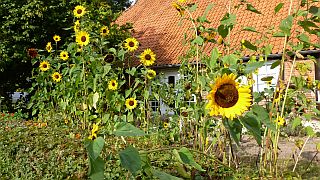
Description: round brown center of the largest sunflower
xmin=214 ymin=84 xmax=239 ymax=108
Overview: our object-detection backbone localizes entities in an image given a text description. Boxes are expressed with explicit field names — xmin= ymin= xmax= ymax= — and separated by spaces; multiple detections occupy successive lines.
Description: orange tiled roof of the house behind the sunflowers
xmin=117 ymin=0 xmax=320 ymax=66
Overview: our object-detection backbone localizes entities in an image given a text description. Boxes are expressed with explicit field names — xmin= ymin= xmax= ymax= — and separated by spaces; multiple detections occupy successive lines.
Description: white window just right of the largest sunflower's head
xmin=252 ymin=62 xmax=280 ymax=92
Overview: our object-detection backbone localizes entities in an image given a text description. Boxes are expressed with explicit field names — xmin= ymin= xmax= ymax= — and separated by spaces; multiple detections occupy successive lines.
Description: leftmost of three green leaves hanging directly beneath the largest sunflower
xmin=222 ymin=119 xmax=242 ymax=146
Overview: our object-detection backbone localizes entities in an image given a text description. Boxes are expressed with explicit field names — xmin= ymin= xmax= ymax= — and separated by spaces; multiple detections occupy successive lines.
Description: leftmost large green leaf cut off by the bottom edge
xmin=88 ymin=157 xmax=105 ymax=180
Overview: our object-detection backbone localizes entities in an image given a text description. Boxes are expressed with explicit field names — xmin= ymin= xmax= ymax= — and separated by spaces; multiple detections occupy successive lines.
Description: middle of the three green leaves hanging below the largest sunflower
xmin=240 ymin=112 xmax=262 ymax=145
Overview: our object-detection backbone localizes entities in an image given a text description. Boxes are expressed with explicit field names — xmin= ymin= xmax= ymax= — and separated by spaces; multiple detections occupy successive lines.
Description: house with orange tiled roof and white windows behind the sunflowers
xmin=117 ymin=0 xmax=320 ymax=114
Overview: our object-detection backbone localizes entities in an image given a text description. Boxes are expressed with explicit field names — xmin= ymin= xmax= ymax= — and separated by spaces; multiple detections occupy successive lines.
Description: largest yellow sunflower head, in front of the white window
xmin=206 ymin=74 xmax=251 ymax=120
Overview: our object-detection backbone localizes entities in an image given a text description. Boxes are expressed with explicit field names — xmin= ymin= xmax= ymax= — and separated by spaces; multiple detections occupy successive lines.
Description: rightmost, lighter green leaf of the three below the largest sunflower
xmin=252 ymin=105 xmax=276 ymax=131
